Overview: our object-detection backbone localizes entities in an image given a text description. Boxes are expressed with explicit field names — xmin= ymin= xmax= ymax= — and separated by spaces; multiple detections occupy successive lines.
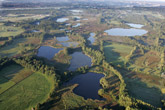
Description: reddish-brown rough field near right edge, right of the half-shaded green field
xmin=129 ymin=51 xmax=161 ymax=75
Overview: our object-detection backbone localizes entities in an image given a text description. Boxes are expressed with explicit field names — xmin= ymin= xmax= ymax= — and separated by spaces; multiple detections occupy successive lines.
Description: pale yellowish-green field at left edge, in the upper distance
xmin=0 ymin=23 xmax=24 ymax=37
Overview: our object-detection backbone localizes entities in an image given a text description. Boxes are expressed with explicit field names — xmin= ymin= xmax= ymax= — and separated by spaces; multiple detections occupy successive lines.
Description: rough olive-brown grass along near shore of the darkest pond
xmin=51 ymin=84 xmax=105 ymax=110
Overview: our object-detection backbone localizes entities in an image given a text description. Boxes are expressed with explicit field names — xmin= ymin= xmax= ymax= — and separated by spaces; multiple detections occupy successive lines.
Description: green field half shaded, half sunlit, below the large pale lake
xmin=104 ymin=43 xmax=133 ymax=65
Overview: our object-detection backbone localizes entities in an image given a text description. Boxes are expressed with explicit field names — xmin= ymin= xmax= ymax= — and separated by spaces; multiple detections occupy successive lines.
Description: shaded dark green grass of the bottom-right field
xmin=126 ymin=79 xmax=161 ymax=107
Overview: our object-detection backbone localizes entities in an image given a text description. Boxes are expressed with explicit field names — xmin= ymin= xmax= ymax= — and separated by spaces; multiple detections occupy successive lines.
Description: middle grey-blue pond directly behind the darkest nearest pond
xmin=68 ymin=52 xmax=92 ymax=71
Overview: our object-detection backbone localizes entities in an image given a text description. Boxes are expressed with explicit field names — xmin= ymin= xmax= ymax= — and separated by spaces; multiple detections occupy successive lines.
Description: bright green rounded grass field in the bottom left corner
xmin=0 ymin=73 xmax=53 ymax=110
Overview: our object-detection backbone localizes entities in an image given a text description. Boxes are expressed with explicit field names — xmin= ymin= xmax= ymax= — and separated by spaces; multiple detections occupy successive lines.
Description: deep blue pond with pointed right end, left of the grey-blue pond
xmin=37 ymin=46 xmax=63 ymax=60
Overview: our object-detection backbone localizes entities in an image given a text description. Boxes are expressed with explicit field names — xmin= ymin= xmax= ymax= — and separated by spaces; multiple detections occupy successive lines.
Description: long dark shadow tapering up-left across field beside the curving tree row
xmin=118 ymin=68 xmax=162 ymax=107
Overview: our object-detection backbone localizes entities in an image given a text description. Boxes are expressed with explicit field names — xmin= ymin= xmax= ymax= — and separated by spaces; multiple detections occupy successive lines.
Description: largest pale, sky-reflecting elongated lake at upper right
xmin=104 ymin=28 xmax=148 ymax=36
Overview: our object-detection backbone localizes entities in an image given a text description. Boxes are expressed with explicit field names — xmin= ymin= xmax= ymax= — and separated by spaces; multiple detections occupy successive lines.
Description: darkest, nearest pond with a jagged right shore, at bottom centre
xmin=67 ymin=72 xmax=104 ymax=100
